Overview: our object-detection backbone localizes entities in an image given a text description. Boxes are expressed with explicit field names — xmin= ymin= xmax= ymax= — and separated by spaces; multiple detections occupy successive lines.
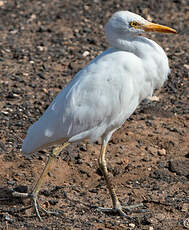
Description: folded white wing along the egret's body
xmin=22 ymin=49 xmax=143 ymax=153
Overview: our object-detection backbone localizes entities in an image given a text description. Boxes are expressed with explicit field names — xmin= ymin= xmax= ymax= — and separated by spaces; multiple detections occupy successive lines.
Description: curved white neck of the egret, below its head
xmin=106 ymin=30 xmax=170 ymax=91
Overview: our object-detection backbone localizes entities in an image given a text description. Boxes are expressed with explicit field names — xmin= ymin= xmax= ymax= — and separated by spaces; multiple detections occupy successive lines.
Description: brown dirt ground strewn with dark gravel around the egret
xmin=0 ymin=0 xmax=189 ymax=230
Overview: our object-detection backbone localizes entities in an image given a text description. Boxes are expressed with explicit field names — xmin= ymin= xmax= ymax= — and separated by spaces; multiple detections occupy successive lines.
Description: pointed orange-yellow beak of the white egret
xmin=142 ymin=22 xmax=177 ymax=34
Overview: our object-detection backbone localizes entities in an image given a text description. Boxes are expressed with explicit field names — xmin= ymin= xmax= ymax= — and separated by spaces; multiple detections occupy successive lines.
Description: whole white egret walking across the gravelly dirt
xmin=17 ymin=11 xmax=176 ymax=219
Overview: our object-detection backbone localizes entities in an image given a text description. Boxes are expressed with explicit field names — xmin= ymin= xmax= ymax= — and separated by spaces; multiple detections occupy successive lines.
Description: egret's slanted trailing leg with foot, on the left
xmin=31 ymin=142 xmax=70 ymax=220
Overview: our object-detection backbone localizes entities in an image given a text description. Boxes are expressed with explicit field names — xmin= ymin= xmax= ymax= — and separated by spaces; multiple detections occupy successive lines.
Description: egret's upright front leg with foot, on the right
xmin=98 ymin=144 xmax=128 ymax=217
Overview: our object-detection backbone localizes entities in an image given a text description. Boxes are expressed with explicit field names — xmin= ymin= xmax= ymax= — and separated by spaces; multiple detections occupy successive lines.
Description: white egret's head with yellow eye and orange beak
xmin=105 ymin=11 xmax=176 ymax=35
